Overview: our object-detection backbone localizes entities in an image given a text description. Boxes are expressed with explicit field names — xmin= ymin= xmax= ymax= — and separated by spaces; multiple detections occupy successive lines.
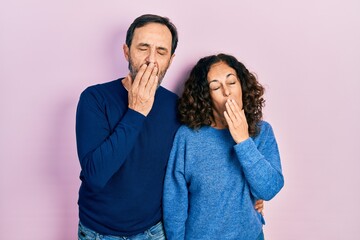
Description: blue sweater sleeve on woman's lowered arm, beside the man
xmin=163 ymin=129 xmax=188 ymax=240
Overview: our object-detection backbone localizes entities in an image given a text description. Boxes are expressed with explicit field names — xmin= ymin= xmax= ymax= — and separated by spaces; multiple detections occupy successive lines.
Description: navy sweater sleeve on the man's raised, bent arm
xmin=76 ymin=88 xmax=145 ymax=191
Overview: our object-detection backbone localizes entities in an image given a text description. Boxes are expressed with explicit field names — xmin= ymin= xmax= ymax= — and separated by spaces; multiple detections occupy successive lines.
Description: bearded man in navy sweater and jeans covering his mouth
xmin=76 ymin=14 xmax=262 ymax=240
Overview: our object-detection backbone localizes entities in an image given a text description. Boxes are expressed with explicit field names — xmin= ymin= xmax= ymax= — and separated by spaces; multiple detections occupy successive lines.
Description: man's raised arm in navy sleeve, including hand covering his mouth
xmin=76 ymin=64 xmax=158 ymax=190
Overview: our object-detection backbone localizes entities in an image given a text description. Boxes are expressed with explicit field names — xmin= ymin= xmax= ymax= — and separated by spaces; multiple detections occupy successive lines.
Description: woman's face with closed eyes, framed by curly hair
xmin=207 ymin=62 xmax=243 ymax=123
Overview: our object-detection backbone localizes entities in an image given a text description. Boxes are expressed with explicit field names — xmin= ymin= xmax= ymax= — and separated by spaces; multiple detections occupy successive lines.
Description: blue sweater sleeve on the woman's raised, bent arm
xmin=234 ymin=123 xmax=284 ymax=200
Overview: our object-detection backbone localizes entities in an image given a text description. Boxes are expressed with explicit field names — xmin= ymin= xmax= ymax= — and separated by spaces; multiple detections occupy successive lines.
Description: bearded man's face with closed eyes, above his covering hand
xmin=124 ymin=23 xmax=174 ymax=84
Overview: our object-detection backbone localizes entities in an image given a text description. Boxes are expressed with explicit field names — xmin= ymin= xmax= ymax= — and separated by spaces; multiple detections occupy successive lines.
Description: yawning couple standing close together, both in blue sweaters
xmin=76 ymin=14 xmax=284 ymax=240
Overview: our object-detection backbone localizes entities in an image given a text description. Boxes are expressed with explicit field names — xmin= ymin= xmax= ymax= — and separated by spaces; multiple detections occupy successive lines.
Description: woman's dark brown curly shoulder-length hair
xmin=178 ymin=53 xmax=265 ymax=136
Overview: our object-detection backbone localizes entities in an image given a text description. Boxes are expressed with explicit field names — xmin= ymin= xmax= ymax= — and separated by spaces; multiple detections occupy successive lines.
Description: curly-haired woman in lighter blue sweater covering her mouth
xmin=163 ymin=54 xmax=284 ymax=240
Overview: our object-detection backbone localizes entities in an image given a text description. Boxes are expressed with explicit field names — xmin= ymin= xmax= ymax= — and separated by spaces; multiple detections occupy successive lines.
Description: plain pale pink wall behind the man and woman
xmin=0 ymin=0 xmax=360 ymax=240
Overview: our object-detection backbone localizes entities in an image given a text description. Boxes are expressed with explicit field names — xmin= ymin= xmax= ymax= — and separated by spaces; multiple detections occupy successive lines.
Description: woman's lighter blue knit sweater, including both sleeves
xmin=163 ymin=121 xmax=284 ymax=240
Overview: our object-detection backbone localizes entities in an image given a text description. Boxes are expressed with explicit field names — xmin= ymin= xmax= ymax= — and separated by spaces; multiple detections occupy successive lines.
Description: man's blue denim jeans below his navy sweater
xmin=78 ymin=222 xmax=165 ymax=240
